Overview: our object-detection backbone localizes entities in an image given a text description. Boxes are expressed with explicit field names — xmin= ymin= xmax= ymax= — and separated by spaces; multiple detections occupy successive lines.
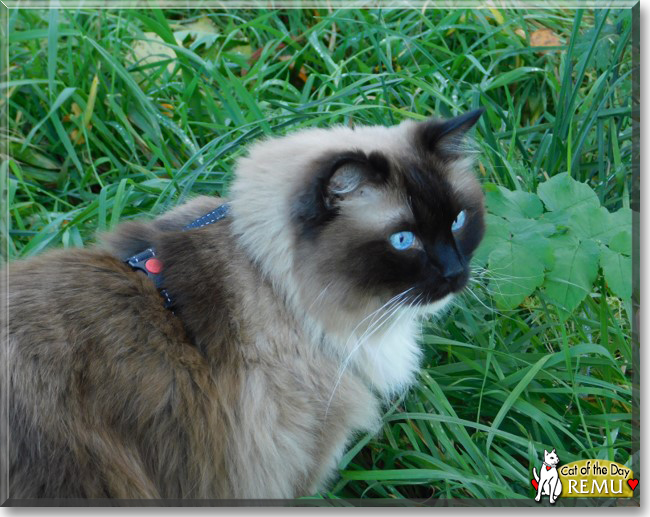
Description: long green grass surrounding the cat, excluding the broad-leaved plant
xmin=0 ymin=9 xmax=634 ymax=499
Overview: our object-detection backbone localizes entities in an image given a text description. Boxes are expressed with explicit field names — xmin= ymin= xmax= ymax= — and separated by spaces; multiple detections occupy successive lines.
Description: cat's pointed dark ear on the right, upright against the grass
xmin=420 ymin=108 xmax=485 ymax=158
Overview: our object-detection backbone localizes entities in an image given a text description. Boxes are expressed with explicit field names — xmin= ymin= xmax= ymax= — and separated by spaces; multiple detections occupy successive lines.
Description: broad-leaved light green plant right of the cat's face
xmin=476 ymin=172 xmax=632 ymax=319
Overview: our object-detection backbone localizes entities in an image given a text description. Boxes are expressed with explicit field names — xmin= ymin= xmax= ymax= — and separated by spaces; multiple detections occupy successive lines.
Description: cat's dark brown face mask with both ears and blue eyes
xmin=291 ymin=110 xmax=484 ymax=304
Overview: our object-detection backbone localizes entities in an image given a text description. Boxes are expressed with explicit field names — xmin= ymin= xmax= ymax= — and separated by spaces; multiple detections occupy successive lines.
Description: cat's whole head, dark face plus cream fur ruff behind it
xmin=231 ymin=110 xmax=484 ymax=332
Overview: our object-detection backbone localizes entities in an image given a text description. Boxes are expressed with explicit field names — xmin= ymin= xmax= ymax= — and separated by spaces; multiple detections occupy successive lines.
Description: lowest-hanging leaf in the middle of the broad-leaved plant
xmin=544 ymin=236 xmax=599 ymax=318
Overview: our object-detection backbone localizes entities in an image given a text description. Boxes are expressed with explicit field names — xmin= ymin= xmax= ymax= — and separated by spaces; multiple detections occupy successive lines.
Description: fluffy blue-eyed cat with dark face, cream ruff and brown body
xmin=0 ymin=111 xmax=484 ymax=499
